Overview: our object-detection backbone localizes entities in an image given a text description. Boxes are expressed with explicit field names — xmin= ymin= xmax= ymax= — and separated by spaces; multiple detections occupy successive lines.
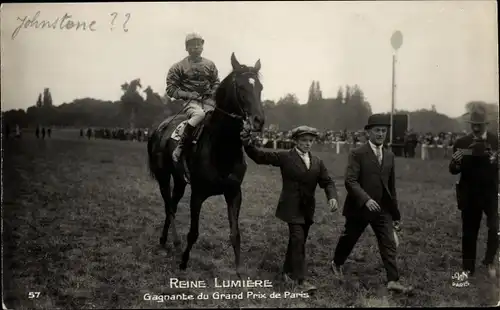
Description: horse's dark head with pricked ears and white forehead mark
xmin=231 ymin=53 xmax=265 ymax=131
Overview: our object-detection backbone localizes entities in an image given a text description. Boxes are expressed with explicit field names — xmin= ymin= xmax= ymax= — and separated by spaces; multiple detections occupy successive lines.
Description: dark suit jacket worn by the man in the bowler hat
xmin=343 ymin=142 xmax=401 ymax=221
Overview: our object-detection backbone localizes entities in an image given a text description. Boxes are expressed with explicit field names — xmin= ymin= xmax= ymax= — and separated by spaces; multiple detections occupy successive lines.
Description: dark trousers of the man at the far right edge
xmin=462 ymin=193 xmax=499 ymax=272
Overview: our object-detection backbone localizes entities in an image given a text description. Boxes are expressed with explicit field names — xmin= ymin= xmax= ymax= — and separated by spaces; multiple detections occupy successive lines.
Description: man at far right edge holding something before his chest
xmin=449 ymin=106 xmax=498 ymax=277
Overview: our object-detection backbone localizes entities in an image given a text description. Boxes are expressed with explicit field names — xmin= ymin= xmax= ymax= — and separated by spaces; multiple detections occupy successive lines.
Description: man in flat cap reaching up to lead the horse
xmin=242 ymin=126 xmax=338 ymax=292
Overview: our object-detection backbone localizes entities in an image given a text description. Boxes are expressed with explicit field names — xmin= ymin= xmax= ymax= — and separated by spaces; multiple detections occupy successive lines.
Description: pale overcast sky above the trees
xmin=1 ymin=0 xmax=499 ymax=117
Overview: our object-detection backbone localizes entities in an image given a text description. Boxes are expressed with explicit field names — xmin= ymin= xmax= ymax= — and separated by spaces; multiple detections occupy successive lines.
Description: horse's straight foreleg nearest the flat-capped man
xmin=224 ymin=189 xmax=243 ymax=276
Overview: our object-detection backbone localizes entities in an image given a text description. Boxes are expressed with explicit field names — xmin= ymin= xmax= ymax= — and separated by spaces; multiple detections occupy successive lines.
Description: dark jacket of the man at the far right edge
xmin=449 ymin=132 xmax=499 ymax=210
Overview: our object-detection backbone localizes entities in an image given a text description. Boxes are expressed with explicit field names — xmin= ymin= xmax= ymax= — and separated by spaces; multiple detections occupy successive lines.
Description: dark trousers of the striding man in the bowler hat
xmin=333 ymin=210 xmax=399 ymax=281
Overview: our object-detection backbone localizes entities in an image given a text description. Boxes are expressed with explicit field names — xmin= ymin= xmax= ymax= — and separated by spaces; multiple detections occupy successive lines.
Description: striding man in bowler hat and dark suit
xmin=331 ymin=114 xmax=411 ymax=292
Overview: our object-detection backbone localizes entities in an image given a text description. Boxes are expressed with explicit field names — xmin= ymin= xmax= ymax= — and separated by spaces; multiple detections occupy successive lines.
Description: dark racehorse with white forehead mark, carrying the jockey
xmin=148 ymin=53 xmax=265 ymax=275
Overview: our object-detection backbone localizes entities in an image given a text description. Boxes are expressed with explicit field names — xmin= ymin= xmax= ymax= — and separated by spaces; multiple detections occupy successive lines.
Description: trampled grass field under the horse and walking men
xmin=3 ymin=132 xmax=499 ymax=309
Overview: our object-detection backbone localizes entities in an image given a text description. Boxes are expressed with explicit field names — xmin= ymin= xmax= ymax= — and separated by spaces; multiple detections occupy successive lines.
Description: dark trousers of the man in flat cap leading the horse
xmin=283 ymin=223 xmax=311 ymax=282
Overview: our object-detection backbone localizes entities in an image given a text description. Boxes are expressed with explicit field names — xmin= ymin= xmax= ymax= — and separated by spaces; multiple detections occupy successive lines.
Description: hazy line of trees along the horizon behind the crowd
xmin=2 ymin=79 xmax=498 ymax=132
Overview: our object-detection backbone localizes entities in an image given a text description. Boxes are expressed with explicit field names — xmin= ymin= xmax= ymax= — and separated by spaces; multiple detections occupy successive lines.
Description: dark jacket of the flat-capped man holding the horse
xmin=245 ymin=145 xmax=338 ymax=224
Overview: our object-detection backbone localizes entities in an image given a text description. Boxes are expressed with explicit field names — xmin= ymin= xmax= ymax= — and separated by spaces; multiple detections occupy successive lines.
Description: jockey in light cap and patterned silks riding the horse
xmin=167 ymin=33 xmax=220 ymax=162
